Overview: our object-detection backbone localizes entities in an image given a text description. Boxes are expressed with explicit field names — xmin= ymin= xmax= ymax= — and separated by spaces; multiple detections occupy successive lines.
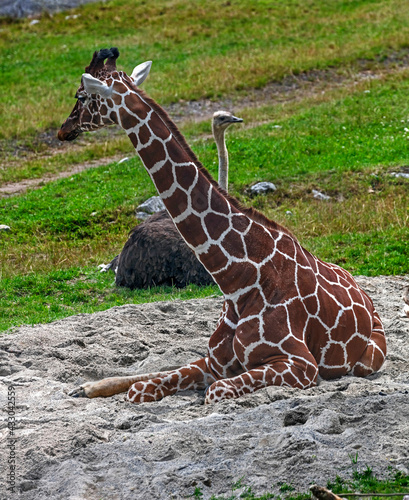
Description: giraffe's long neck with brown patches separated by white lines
xmin=121 ymin=94 xmax=252 ymax=292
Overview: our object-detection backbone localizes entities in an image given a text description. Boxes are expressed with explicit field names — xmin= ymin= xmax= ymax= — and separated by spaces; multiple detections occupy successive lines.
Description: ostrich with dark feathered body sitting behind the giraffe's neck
xmin=110 ymin=111 xmax=243 ymax=289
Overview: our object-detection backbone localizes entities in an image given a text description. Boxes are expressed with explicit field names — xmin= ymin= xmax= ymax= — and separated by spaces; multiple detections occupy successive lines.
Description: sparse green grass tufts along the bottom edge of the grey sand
xmin=190 ymin=466 xmax=409 ymax=500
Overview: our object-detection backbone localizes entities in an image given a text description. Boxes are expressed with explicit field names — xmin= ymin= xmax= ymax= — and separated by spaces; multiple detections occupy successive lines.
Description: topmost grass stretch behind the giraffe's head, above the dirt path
xmin=0 ymin=0 xmax=409 ymax=149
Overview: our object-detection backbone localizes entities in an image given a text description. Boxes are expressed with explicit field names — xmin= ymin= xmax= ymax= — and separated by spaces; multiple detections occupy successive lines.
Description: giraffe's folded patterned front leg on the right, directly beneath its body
xmin=205 ymin=360 xmax=318 ymax=404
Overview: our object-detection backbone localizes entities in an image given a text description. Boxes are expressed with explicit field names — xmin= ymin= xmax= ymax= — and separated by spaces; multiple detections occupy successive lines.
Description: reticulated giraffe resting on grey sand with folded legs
xmin=58 ymin=48 xmax=386 ymax=403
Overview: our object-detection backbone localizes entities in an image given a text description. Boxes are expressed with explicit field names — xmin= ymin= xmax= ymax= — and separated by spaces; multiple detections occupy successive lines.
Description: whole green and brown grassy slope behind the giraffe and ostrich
xmin=0 ymin=1 xmax=409 ymax=329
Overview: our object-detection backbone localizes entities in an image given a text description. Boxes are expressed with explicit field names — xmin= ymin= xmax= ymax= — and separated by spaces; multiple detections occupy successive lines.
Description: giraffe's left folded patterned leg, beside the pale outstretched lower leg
xmin=127 ymin=358 xmax=215 ymax=403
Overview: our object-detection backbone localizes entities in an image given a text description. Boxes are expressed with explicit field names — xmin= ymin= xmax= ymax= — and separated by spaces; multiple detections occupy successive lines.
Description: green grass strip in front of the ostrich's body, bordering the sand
xmin=0 ymin=267 xmax=220 ymax=331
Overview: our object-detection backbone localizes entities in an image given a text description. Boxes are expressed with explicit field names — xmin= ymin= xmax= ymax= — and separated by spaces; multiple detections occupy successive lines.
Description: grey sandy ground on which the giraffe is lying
xmin=0 ymin=277 xmax=409 ymax=500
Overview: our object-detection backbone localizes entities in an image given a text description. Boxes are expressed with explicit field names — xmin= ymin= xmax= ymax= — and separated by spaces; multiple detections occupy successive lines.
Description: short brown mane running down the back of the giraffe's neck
xmin=134 ymin=87 xmax=296 ymax=240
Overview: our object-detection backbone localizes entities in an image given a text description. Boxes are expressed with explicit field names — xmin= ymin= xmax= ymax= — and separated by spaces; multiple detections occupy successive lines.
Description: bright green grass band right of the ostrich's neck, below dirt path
xmin=192 ymin=72 xmax=409 ymax=186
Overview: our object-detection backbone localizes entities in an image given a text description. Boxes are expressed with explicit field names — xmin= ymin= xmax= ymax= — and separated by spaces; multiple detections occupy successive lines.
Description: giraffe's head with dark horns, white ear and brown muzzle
xmin=58 ymin=47 xmax=152 ymax=141
